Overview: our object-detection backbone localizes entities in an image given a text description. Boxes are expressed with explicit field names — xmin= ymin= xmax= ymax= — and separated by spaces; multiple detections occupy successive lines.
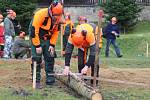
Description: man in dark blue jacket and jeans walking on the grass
xmin=104 ymin=17 xmax=122 ymax=57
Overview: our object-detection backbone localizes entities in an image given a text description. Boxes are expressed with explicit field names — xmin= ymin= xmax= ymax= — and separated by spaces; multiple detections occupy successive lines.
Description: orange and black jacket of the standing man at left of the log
xmin=32 ymin=8 xmax=59 ymax=47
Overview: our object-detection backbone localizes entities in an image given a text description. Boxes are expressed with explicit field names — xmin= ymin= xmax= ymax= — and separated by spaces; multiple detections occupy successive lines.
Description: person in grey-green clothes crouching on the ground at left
xmin=12 ymin=31 xmax=31 ymax=59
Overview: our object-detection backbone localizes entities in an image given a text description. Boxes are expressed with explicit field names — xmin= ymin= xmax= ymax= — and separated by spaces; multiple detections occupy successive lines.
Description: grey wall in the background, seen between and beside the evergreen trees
xmin=64 ymin=6 xmax=150 ymax=22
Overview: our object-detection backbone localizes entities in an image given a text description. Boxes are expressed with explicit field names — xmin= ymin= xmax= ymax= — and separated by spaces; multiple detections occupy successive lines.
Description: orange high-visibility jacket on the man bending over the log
xmin=68 ymin=23 xmax=95 ymax=48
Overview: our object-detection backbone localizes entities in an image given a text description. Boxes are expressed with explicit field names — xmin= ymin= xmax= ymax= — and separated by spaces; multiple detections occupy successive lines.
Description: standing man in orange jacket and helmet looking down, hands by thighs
xmin=30 ymin=1 xmax=63 ymax=88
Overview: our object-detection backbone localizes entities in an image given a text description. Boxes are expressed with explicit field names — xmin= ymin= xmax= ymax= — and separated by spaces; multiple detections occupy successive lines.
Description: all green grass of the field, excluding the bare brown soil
xmin=0 ymin=21 xmax=150 ymax=100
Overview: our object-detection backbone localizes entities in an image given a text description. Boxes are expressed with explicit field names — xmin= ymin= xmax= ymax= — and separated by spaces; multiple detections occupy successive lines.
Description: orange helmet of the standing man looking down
xmin=51 ymin=2 xmax=63 ymax=15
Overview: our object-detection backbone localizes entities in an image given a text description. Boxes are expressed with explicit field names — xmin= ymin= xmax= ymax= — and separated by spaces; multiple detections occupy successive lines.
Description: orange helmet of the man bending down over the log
xmin=71 ymin=29 xmax=85 ymax=48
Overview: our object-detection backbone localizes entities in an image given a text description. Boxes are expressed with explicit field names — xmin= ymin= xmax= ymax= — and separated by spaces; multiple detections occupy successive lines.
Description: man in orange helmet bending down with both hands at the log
xmin=64 ymin=23 xmax=98 ymax=84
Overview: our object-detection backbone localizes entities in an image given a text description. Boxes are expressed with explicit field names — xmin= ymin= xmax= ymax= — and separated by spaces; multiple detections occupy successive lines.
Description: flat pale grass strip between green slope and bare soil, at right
xmin=101 ymin=57 xmax=150 ymax=68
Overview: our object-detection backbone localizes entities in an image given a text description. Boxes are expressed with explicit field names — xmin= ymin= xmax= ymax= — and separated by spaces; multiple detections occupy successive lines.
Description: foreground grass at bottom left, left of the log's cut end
xmin=0 ymin=87 xmax=83 ymax=100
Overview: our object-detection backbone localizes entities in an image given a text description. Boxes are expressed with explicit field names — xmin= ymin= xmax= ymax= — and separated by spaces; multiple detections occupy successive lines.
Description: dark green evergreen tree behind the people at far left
xmin=0 ymin=0 xmax=36 ymax=32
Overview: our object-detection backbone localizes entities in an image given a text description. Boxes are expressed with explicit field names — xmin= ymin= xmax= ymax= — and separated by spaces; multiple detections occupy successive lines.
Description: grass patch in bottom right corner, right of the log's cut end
xmin=102 ymin=87 xmax=150 ymax=100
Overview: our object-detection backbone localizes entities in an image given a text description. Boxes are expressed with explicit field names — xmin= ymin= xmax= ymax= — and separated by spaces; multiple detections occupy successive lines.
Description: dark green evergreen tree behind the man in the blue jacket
xmin=102 ymin=0 xmax=142 ymax=32
